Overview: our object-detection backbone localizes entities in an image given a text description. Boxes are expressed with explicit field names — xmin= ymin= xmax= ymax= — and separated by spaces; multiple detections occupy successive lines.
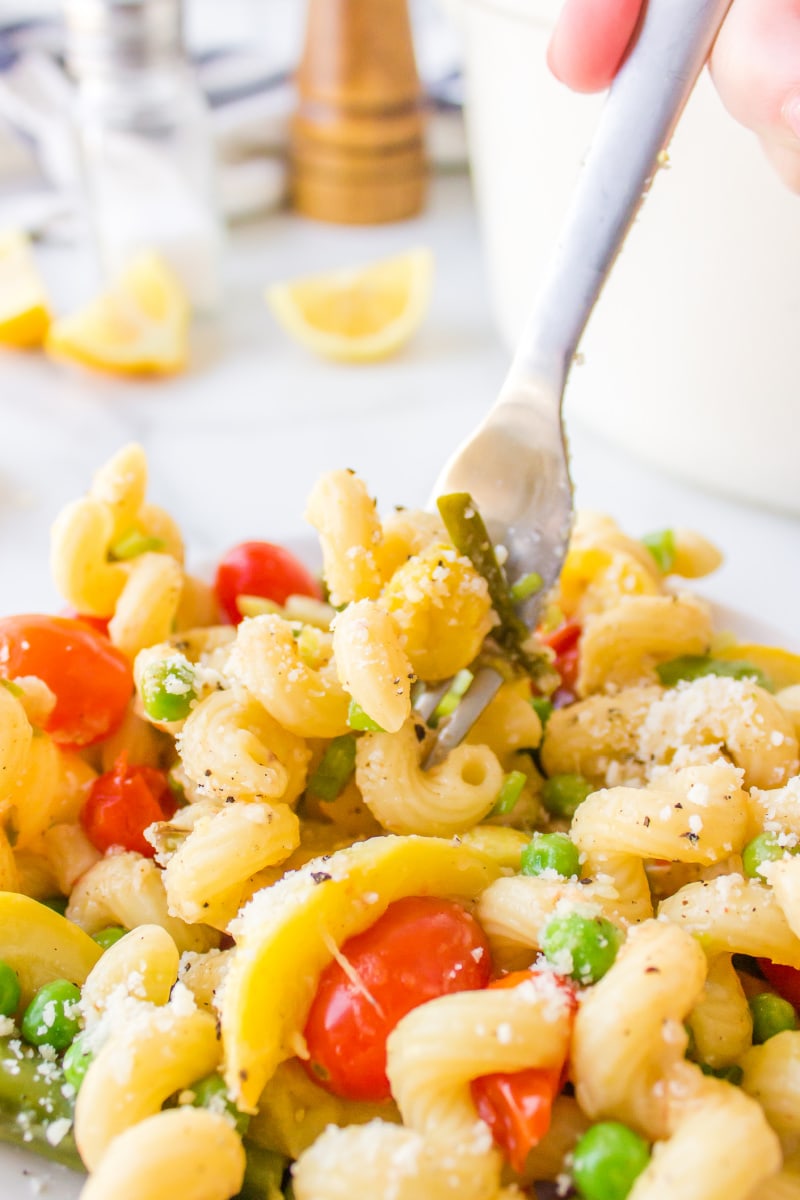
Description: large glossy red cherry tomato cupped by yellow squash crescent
xmin=305 ymin=896 xmax=492 ymax=1100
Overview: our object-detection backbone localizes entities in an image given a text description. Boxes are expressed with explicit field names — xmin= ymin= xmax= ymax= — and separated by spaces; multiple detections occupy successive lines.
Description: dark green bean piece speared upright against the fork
xmin=437 ymin=492 xmax=548 ymax=677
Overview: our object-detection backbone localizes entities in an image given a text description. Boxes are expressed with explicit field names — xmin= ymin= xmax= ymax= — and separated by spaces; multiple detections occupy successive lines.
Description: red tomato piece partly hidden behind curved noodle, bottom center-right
xmin=470 ymin=971 xmax=577 ymax=1171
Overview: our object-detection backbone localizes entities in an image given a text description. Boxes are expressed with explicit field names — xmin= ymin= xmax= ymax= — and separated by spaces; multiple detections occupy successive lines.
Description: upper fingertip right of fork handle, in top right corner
xmin=711 ymin=0 xmax=800 ymax=144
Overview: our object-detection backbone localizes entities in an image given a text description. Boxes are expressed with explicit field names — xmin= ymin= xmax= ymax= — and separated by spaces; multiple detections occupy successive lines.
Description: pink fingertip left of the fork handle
xmin=547 ymin=0 xmax=643 ymax=91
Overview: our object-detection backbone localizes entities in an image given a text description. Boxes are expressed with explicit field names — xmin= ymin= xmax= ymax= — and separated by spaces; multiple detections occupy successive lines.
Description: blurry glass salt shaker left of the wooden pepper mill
xmin=64 ymin=0 xmax=222 ymax=311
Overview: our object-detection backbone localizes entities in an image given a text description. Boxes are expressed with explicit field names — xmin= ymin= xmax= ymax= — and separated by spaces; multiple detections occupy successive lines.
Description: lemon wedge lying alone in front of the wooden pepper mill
xmin=266 ymin=250 xmax=433 ymax=362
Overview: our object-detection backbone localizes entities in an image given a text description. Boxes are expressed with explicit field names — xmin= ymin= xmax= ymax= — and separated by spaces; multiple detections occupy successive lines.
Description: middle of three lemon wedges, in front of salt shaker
xmin=46 ymin=253 xmax=190 ymax=374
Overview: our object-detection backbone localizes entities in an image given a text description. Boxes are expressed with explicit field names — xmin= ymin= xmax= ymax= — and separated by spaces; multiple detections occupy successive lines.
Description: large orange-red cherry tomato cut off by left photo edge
xmin=0 ymin=616 xmax=133 ymax=746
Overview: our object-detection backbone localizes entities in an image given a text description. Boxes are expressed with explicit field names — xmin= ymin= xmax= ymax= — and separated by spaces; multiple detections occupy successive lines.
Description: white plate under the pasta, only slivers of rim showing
xmin=0 ymin=600 xmax=800 ymax=1200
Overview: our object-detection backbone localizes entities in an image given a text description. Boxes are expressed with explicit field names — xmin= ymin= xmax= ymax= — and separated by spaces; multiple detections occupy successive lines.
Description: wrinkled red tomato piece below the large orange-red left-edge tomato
xmin=80 ymin=751 xmax=175 ymax=858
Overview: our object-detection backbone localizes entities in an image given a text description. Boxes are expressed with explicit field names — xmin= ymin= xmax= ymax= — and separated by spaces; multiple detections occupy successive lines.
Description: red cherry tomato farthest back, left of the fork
xmin=215 ymin=541 xmax=323 ymax=625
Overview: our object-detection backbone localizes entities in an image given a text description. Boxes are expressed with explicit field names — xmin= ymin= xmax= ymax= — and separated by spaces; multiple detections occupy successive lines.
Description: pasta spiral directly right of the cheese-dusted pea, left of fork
xmin=228 ymin=613 xmax=349 ymax=738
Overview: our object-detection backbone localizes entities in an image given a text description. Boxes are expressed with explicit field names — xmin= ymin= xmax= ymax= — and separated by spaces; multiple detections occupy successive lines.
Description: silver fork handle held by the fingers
xmin=512 ymin=0 xmax=732 ymax=384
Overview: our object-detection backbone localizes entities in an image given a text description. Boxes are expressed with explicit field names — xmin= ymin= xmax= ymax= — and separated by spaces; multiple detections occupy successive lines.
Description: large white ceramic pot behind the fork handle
xmin=450 ymin=0 xmax=800 ymax=514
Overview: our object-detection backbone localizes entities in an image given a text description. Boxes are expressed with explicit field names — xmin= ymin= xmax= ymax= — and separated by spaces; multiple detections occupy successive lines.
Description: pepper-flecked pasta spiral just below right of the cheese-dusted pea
xmin=178 ymin=688 xmax=309 ymax=804
